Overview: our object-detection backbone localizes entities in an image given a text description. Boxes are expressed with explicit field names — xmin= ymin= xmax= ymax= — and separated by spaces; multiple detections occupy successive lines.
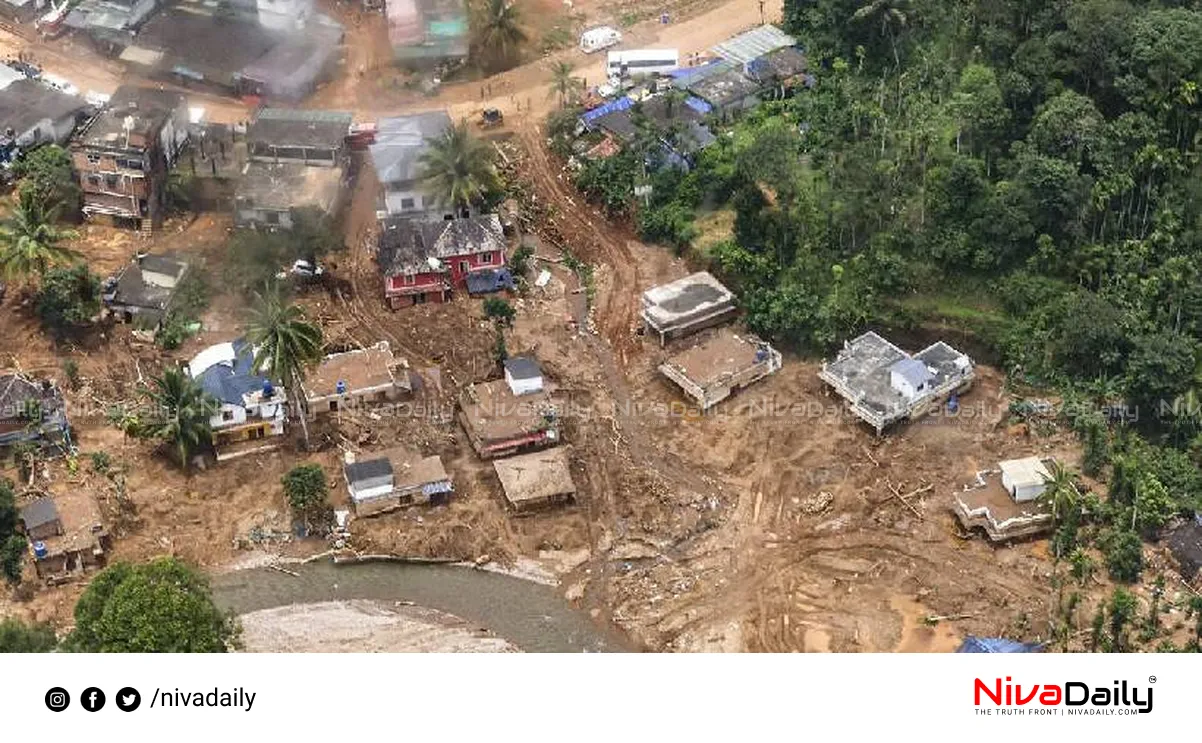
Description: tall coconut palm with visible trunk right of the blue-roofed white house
xmin=246 ymin=286 xmax=322 ymax=444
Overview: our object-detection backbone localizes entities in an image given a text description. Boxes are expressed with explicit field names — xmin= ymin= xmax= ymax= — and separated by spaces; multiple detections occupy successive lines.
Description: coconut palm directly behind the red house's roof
xmin=419 ymin=120 xmax=500 ymax=210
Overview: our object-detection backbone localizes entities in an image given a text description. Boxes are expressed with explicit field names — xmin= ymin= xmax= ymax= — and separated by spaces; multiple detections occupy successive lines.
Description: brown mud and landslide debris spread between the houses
xmin=0 ymin=0 xmax=1144 ymax=650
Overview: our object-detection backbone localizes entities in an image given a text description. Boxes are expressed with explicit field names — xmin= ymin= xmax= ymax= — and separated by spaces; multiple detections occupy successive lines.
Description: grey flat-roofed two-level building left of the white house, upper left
xmin=234 ymin=108 xmax=351 ymax=230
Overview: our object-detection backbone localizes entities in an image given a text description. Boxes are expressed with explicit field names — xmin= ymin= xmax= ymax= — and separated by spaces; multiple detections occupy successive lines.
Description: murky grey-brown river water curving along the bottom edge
xmin=212 ymin=561 xmax=631 ymax=653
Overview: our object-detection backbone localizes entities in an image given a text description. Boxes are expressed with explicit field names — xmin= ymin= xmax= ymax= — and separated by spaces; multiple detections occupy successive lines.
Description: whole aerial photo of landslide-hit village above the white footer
xmin=0 ymin=0 xmax=1202 ymax=652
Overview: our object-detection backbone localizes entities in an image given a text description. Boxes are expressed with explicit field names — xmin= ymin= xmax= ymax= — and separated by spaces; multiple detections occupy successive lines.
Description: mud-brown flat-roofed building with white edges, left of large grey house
xmin=660 ymin=329 xmax=781 ymax=410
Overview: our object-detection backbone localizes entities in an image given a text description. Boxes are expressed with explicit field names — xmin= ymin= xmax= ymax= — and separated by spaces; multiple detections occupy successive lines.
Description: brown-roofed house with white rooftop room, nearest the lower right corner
xmin=952 ymin=457 xmax=1052 ymax=542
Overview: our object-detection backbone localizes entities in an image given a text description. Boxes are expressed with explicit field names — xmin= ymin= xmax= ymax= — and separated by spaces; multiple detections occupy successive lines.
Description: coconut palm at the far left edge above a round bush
xmin=0 ymin=189 xmax=78 ymax=280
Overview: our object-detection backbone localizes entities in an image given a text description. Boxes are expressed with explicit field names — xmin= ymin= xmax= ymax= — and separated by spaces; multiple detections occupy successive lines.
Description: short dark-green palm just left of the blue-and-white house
xmin=138 ymin=369 xmax=221 ymax=470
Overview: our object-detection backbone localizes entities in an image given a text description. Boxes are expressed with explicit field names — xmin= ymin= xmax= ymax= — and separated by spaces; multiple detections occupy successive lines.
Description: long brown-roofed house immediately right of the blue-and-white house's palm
xmin=302 ymin=341 xmax=412 ymax=417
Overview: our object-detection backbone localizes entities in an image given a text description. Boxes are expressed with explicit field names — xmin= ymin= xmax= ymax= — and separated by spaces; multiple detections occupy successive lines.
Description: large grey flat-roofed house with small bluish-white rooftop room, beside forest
xmin=819 ymin=332 xmax=974 ymax=434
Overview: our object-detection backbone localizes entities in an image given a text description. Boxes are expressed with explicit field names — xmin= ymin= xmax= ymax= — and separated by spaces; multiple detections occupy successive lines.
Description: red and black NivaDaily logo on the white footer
xmin=972 ymin=676 xmax=1156 ymax=715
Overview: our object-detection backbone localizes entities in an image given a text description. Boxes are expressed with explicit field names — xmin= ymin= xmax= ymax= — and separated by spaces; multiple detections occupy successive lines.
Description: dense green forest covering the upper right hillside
xmin=562 ymin=0 xmax=1202 ymax=603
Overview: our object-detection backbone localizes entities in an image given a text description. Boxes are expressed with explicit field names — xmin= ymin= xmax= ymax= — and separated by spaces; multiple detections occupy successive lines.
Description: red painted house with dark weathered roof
xmin=376 ymin=214 xmax=505 ymax=309
